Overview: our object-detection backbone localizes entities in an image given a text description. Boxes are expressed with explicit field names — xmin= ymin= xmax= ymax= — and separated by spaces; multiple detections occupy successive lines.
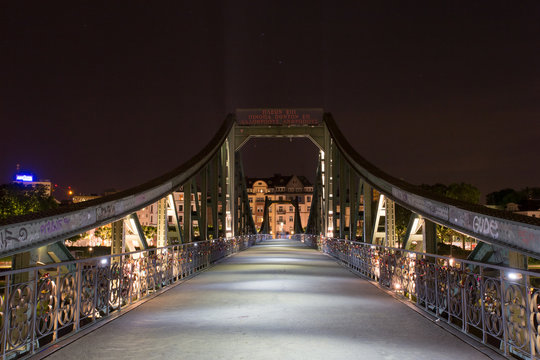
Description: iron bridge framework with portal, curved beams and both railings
xmin=0 ymin=109 xmax=540 ymax=358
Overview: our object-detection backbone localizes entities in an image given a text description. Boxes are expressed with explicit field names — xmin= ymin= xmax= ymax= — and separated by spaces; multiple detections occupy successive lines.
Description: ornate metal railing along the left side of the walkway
xmin=0 ymin=235 xmax=265 ymax=359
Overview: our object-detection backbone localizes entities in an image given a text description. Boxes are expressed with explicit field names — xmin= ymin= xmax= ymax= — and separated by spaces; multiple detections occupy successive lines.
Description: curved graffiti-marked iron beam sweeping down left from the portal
xmin=0 ymin=114 xmax=235 ymax=256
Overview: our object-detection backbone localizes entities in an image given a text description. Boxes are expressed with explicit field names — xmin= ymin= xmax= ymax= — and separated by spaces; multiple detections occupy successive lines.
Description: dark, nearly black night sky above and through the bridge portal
xmin=0 ymin=0 xmax=540 ymax=200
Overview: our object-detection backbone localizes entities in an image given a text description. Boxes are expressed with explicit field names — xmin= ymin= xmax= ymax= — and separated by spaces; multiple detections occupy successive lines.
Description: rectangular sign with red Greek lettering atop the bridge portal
xmin=236 ymin=108 xmax=323 ymax=125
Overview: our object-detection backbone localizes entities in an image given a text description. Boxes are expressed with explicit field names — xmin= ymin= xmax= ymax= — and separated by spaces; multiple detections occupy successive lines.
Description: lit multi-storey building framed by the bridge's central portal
xmin=247 ymin=174 xmax=313 ymax=234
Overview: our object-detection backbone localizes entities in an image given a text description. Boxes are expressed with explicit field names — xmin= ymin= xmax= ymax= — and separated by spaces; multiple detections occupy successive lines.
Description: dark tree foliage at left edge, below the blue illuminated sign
xmin=0 ymin=184 xmax=58 ymax=219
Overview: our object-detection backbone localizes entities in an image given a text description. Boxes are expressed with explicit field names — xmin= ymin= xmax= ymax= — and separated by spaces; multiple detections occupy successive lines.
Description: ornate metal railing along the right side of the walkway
xmin=294 ymin=235 xmax=540 ymax=359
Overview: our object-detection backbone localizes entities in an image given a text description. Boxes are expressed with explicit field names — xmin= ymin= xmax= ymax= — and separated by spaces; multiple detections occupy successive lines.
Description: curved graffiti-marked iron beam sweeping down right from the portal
xmin=324 ymin=113 xmax=540 ymax=257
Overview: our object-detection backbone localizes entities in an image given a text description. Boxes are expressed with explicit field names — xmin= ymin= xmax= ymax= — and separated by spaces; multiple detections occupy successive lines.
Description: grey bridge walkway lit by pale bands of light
xmin=38 ymin=239 xmax=502 ymax=360
